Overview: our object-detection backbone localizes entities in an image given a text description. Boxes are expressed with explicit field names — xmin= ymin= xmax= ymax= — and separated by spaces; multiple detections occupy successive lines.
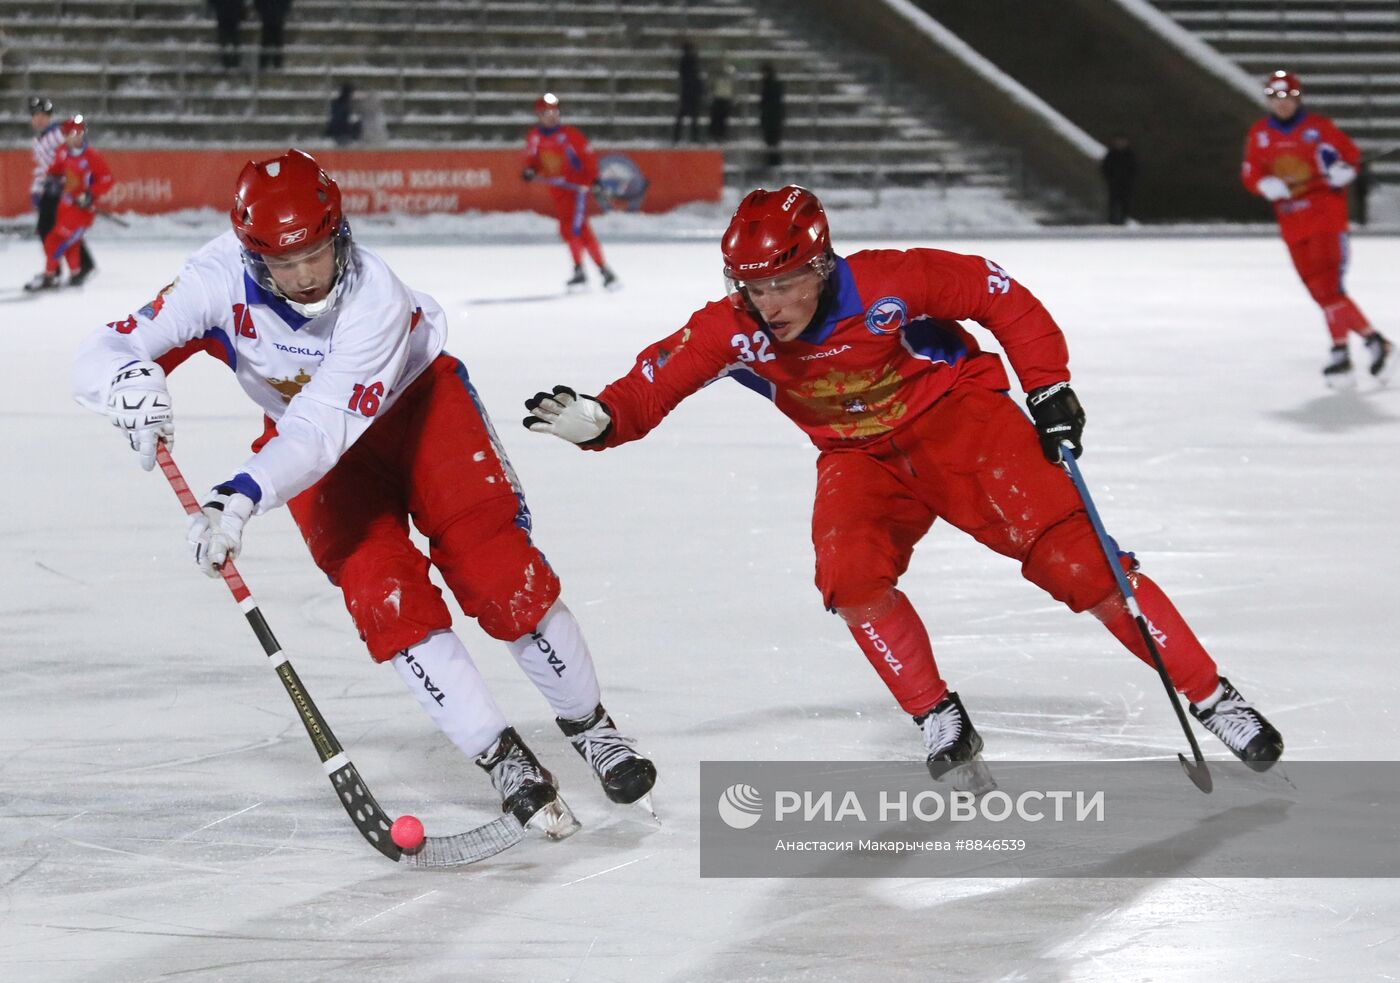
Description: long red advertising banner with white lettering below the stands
xmin=0 ymin=147 xmax=724 ymax=216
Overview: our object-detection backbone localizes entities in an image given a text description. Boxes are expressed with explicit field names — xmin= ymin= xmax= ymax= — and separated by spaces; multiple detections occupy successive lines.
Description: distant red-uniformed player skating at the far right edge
xmin=1240 ymin=71 xmax=1394 ymax=389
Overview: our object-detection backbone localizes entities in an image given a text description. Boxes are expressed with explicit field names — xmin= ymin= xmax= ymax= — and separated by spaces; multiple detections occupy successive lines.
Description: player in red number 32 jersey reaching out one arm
xmin=525 ymin=186 xmax=1284 ymax=779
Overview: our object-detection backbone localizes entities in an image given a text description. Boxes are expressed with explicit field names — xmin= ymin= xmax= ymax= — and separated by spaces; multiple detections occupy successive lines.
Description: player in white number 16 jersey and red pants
xmin=74 ymin=150 xmax=657 ymax=836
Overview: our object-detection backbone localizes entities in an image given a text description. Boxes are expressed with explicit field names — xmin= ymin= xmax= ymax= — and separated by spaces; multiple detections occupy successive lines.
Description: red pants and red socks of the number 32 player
xmin=812 ymin=385 xmax=1217 ymax=713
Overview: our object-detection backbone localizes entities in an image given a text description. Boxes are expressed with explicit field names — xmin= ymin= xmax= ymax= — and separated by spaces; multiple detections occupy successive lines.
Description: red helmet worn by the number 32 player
xmin=720 ymin=185 xmax=832 ymax=286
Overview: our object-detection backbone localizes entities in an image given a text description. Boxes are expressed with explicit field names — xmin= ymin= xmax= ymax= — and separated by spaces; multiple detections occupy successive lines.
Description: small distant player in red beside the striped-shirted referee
xmin=24 ymin=116 xmax=112 ymax=291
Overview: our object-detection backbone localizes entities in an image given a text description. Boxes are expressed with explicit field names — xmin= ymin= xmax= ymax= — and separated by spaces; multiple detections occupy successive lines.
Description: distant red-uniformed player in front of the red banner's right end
xmin=521 ymin=92 xmax=620 ymax=290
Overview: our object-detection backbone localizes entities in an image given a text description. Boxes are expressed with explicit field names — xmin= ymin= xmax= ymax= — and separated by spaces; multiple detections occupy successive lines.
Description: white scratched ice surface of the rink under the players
xmin=0 ymin=225 xmax=1400 ymax=983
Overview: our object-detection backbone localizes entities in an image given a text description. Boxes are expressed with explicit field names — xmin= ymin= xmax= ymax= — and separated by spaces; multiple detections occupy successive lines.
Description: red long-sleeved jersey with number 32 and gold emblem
xmin=598 ymin=249 xmax=1070 ymax=449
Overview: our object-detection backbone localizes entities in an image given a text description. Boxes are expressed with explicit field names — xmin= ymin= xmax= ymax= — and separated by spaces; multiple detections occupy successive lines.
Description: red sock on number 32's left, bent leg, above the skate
xmin=837 ymin=591 xmax=948 ymax=717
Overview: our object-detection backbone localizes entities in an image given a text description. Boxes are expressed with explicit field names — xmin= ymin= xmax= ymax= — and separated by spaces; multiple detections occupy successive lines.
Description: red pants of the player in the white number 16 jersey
xmin=255 ymin=354 xmax=559 ymax=662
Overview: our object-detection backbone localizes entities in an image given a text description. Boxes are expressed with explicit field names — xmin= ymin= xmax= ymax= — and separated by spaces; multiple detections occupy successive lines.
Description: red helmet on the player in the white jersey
xmin=228 ymin=150 xmax=349 ymax=256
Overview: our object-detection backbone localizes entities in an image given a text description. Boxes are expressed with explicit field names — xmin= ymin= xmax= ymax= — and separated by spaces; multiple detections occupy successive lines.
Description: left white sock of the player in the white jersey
xmin=393 ymin=630 xmax=507 ymax=758
